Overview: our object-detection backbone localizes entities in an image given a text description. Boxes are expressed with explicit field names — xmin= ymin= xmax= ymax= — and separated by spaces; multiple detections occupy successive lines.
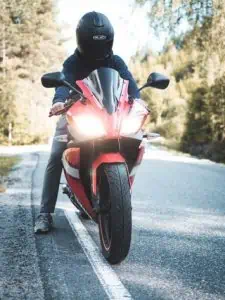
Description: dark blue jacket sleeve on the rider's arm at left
xmin=52 ymin=56 xmax=75 ymax=104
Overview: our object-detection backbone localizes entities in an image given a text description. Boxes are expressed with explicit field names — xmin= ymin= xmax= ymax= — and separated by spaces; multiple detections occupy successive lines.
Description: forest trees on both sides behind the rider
xmin=0 ymin=0 xmax=225 ymax=162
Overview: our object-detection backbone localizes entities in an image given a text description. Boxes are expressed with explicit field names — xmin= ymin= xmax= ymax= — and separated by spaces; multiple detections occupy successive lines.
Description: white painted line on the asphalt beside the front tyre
xmin=64 ymin=210 xmax=132 ymax=300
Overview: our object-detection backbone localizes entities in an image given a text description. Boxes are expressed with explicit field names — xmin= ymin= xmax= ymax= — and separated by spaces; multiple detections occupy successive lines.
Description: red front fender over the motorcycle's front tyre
xmin=92 ymin=153 xmax=126 ymax=196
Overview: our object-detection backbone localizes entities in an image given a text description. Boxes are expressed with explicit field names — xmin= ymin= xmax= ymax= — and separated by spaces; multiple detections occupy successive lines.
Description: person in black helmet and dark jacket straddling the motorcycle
xmin=35 ymin=12 xmax=140 ymax=233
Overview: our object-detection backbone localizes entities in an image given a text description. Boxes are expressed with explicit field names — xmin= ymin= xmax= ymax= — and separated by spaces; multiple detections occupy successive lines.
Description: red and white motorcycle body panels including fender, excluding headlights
xmin=61 ymin=75 xmax=148 ymax=218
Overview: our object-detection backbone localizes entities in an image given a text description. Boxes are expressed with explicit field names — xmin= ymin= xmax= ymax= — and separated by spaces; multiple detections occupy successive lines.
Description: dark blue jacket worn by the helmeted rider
xmin=53 ymin=50 xmax=140 ymax=104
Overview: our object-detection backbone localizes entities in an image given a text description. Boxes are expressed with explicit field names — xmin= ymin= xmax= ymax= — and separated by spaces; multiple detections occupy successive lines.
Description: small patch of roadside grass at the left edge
xmin=0 ymin=156 xmax=20 ymax=193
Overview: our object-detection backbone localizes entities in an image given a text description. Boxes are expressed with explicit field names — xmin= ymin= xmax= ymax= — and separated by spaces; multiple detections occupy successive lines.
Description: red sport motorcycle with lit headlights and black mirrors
xmin=42 ymin=68 xmax=169 ymax=264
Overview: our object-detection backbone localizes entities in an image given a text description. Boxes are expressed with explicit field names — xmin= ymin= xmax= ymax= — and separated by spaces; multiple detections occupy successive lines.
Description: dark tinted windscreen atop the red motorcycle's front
xmin=84 ymin=68 xmax=123 ymax=114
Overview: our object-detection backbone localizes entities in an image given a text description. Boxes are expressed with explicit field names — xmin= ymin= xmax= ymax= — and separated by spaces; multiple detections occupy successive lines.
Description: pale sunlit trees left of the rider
xmin=0 ymin=0 xmax=63 ymax=144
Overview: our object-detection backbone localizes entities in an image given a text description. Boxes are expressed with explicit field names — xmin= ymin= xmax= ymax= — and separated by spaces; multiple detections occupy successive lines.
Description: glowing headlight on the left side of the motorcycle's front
xmin=73 ymin=115 xmax=105 ymax=137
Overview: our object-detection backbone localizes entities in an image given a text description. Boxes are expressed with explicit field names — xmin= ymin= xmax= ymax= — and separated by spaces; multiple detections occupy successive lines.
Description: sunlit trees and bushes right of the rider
xmin=132 ymin=0 xmax=225 ymax=162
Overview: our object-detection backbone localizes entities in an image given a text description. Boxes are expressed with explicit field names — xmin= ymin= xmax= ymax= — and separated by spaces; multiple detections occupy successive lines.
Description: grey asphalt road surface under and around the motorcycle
xmin=0 ymin=144 xmax=225 ymax=300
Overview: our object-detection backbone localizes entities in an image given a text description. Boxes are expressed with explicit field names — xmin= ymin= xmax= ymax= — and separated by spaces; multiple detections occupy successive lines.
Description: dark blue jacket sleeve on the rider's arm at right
xmin=115 ymin=55 xmax=140 ymax=98
